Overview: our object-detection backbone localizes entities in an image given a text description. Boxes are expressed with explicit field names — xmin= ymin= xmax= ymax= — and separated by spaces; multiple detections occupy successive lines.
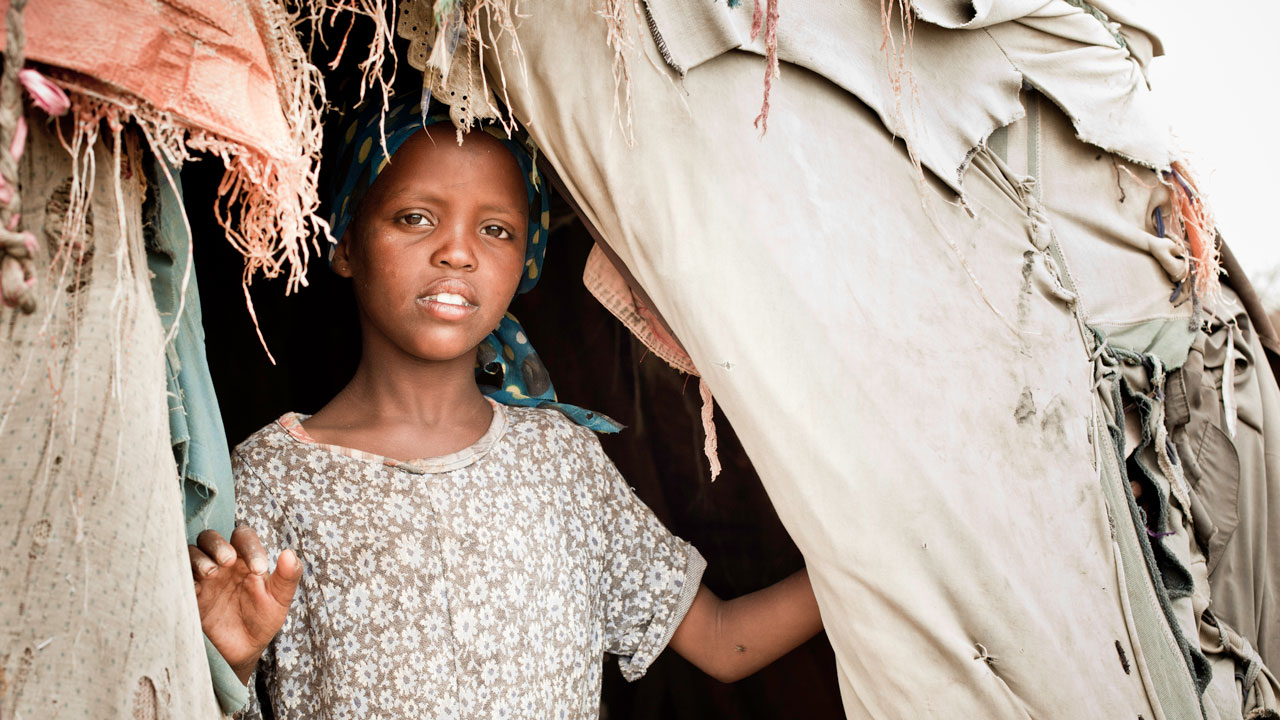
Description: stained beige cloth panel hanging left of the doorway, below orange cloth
xmin=0 ymin=118 xmax=220 ymax=719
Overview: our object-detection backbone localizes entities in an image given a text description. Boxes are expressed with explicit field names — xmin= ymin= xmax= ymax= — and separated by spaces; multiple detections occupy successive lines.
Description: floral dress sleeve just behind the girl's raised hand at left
xmin=232 ymin=448 xmax=311 ymax=720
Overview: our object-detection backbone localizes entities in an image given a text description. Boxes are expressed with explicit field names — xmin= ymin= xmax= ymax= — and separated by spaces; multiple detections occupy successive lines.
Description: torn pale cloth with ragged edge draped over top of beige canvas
xmin=645 ymin=0 xmax=1172 ymax=192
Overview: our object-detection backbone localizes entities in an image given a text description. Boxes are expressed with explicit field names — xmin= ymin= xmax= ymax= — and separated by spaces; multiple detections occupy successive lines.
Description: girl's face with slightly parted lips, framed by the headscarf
xmin=333 ymin=126 xmax=529 ymax=363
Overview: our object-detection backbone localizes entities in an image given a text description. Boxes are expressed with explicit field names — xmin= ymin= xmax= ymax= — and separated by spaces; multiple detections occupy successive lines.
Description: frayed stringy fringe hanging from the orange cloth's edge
xmin=16 ymin=0 xmax=335 ymax=361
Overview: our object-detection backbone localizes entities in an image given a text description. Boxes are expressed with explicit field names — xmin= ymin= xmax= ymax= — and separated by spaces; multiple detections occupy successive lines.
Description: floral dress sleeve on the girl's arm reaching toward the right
xmin=591 ymin=437 xmax=707 ymax=680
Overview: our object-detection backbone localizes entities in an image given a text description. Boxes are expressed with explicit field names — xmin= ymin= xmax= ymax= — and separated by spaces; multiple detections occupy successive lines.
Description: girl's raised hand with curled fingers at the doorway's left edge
xmin=187 ymin=525 xmax=302 ymax=684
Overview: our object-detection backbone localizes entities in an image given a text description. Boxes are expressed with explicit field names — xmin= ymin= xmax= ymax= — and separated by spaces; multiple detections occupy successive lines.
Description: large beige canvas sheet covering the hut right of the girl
xmin=486 ymin=0 xmax=1274 ymax=720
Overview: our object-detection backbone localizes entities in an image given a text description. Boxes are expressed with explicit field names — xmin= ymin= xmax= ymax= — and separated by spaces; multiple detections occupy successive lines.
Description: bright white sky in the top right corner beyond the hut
xmin=1143 ymin=0 xmax=1280 ymax=302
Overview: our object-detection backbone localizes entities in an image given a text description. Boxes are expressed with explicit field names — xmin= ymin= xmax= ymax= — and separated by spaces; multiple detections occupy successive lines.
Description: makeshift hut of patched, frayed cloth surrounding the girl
xmin=0 ymin=0 xmax=1280 ymax=720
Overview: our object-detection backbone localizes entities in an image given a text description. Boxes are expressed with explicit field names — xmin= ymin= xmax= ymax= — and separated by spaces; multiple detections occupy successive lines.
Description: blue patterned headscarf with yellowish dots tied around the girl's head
xmin=329 ymin=100 xmax=621 ymax=433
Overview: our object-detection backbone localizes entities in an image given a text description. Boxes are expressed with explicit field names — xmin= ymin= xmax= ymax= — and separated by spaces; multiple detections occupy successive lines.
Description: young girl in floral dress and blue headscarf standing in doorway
xmin=189 ymin=98 xmax=820 ymax=720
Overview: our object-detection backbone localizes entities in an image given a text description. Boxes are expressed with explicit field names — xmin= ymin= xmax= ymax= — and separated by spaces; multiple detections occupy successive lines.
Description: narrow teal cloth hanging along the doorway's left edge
xmin=143 ymin=161 xmax=248 ymax=715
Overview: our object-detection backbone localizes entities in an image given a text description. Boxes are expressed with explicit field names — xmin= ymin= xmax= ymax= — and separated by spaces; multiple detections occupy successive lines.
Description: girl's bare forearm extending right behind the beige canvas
xmin=671 ymin=570 xmax=822 ymax=683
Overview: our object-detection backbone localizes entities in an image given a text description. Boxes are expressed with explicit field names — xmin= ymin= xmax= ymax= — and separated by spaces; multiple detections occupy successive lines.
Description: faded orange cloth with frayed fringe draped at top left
xmin=0 ymin=0 xmax=328 ymax=296
